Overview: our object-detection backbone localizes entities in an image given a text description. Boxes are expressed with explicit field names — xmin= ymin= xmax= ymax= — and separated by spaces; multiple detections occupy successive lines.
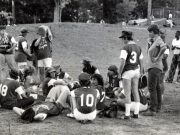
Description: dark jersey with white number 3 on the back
xmin=122 ymin=43 xmax=142 ymax=72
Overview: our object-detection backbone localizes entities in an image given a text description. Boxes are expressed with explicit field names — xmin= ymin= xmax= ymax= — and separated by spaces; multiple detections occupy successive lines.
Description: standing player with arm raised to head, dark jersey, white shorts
xmin=35 ymin=26 xmax=52 ymax=82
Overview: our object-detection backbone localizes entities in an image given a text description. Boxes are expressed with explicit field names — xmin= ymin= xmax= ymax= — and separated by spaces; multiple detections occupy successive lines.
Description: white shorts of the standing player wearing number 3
xmin=122 ymin=68 xmax=140 ymax=80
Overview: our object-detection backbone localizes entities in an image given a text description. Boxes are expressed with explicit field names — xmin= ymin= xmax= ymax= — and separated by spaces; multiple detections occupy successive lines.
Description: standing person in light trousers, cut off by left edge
xmin=0 ymin=25 xmax=17 ymax=81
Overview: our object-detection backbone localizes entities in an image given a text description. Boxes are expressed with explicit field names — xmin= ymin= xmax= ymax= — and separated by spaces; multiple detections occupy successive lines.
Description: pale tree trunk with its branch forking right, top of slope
xmin=54 ymin=0 xmax=71 ymax=22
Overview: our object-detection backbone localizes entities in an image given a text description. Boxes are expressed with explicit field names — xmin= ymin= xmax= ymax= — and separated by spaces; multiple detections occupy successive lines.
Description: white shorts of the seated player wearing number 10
xmin=74 ymin=108 xmax=96 ymax=120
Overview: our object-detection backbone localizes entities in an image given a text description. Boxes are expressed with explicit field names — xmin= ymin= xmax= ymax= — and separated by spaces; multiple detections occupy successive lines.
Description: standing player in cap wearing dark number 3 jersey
xmin=119 ymin=31 xmax=143 ymax=120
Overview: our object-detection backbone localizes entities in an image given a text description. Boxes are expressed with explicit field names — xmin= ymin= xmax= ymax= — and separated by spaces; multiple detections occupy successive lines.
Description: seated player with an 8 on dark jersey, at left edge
xmin=0 ymin=70 xmax=34 ymax=109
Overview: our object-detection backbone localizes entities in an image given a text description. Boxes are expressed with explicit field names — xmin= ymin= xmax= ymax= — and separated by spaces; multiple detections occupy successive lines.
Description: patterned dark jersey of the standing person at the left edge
xmin=0 ymin=35 xmax=13 ymax=54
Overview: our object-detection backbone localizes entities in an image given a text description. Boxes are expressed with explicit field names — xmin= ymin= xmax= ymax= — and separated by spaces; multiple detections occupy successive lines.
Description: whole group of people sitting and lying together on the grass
xmin=0 ymin=59 xmax=148 ymax=123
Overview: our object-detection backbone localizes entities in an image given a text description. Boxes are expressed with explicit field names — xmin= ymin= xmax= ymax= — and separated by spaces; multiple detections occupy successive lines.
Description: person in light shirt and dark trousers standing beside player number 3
xmin=143 ymin=24 xmax=166 ymax=116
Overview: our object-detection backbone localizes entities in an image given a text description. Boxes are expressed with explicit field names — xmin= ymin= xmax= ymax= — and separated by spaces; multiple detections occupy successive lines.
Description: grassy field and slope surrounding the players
xmin=0 ymin=23 xmax=180 ymax=135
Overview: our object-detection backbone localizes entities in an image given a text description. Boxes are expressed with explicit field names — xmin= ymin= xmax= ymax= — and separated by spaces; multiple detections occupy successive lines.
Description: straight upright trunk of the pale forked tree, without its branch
xmin=54 ymin=0 xmax=60 ymax=22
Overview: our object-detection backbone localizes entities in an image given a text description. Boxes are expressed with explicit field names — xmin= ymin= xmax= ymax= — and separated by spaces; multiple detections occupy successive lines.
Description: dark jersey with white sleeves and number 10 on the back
xmin=72 ymin=87 xmax=99 ymax=114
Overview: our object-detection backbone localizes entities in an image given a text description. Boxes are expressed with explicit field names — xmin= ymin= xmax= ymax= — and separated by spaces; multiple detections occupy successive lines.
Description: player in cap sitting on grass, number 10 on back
xmin=68 ymin=73 xmax=100 ymax=123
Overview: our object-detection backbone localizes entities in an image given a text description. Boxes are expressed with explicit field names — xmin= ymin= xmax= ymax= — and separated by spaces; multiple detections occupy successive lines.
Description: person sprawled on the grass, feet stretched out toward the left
xmin=13 ymin=85 xmax=70 ymax=122
